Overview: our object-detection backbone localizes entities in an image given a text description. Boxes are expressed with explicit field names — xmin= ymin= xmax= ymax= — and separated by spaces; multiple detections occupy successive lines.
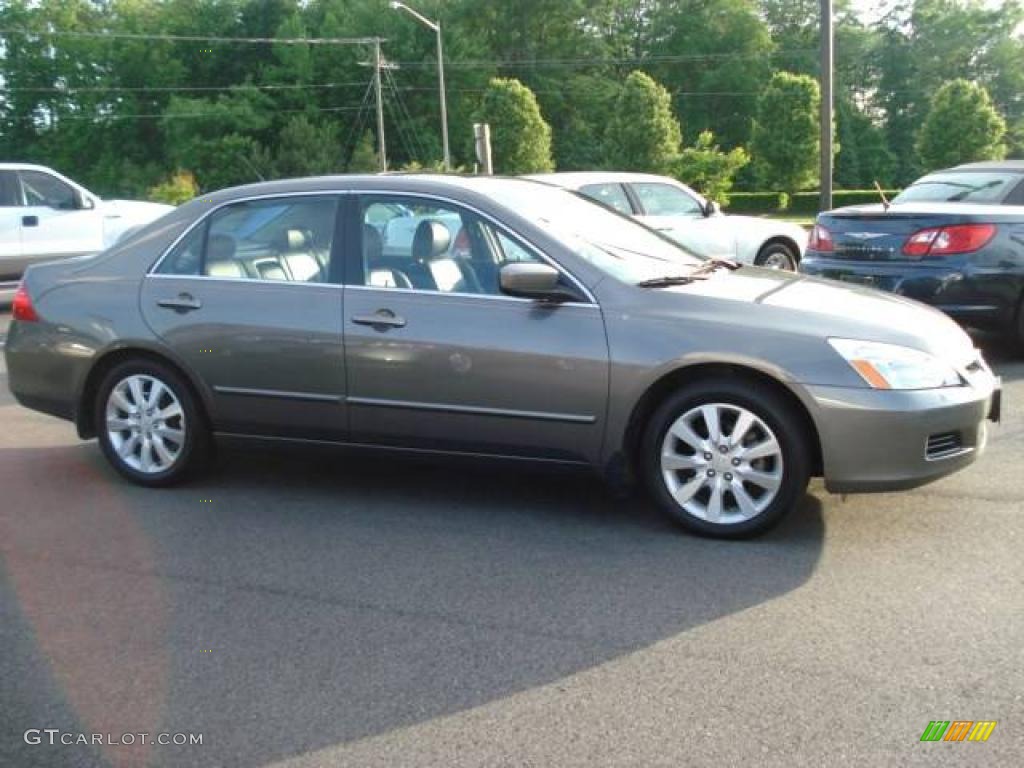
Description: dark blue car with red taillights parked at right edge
xmin=801 ymin=160 xmax=1024 ymax=346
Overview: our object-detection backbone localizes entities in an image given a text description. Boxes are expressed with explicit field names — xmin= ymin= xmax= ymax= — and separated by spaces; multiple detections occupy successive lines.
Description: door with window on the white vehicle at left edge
xmin=18 ymin=170 xmax=103 ymax=261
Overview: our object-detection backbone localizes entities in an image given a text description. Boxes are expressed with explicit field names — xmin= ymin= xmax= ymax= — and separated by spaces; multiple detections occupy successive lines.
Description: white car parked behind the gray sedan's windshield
xmin=530 ymin=171 xmax=807 ymax=270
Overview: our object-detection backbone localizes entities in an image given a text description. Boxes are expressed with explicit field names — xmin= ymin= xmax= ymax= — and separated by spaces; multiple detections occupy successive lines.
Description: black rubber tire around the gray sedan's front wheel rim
xmin=641 ymin=378 xmax=810 ymax=539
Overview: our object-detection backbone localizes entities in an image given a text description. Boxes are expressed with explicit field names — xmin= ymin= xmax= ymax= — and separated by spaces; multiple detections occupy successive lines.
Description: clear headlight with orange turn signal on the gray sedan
xmin=828 ymin=339 xmax=964 ymax=389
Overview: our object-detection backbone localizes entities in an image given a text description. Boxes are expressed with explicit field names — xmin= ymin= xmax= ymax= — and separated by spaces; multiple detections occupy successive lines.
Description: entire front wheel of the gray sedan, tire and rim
xmin=643 ymin=379 xmax=810 ymax=539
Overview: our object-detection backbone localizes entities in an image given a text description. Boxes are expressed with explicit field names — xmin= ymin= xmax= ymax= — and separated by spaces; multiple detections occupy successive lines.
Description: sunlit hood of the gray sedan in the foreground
xmin=653 ymin=266 xmax=977 ymax=367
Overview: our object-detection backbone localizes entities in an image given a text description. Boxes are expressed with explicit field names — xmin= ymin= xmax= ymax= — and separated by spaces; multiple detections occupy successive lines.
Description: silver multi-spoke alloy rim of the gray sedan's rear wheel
xmin=106 ymin=374 xmax=185 ymax=474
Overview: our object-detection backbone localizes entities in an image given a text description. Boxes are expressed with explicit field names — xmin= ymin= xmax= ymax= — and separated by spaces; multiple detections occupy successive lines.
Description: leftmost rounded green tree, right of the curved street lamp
xmin=474 ymin=78 xmax=555 ymax=174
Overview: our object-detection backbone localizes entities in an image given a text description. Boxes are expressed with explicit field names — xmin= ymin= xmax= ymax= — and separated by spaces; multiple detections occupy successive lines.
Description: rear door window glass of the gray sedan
xmin=157 ymin=197 xmax=338 ymax=283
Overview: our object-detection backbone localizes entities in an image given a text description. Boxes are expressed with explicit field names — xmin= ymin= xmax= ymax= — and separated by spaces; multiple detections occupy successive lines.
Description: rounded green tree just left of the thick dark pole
xmin=751 ymin=72 xmax=821 ymax=194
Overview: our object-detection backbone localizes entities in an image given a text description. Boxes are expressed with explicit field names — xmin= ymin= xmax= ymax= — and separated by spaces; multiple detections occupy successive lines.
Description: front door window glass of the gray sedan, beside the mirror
xmin=360 ymin=196 xmax=541 ymax=296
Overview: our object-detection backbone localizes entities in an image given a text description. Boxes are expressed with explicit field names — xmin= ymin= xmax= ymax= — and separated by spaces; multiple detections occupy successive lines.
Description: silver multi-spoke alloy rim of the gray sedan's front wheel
xmin=660 ymin=402 xmax=783 ymax=525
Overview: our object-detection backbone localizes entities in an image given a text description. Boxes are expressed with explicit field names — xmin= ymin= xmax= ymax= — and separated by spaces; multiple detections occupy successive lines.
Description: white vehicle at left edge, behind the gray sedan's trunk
xmin=0 ymin=163 xmax=173 ymax=303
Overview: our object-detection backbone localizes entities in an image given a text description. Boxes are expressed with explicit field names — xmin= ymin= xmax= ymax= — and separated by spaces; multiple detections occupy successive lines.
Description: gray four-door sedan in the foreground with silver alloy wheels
xmin=4 ymin=175 xmax=999 ymax=537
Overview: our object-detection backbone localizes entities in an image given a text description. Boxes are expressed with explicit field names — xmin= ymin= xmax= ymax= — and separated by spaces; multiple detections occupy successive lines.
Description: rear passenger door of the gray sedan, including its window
xmin=141 ymin=195 xmax=347 ymax=440
